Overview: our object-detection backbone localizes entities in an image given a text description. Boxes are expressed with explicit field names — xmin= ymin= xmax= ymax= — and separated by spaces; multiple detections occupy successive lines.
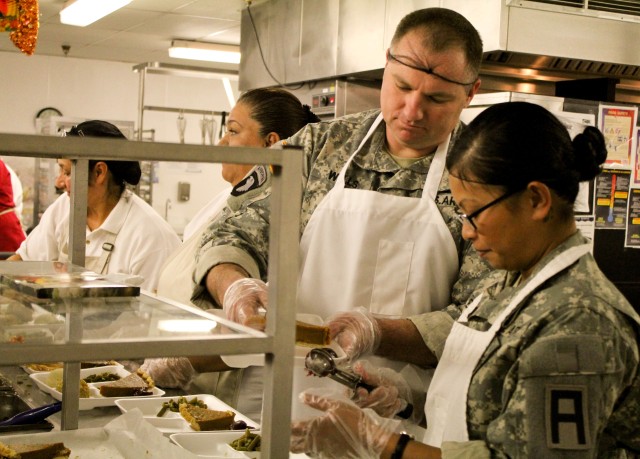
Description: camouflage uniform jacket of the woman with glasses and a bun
xmin=443 ymin=232 xmax=640 ymax=458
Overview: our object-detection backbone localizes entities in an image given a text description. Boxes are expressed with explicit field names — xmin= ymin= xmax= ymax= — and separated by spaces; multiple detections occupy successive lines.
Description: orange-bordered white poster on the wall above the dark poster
xmin=598 ymin=105 xmax=638 ymax=166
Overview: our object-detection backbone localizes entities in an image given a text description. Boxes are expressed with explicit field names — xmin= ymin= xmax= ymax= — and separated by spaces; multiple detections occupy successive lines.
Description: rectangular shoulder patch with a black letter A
xmin=545 ymin=385 xmax=593 ymax=450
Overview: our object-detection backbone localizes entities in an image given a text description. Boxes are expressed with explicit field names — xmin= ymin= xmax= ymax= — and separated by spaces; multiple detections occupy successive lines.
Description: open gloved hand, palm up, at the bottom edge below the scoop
xmin=291 ymin=390 xmax=399 ymax=459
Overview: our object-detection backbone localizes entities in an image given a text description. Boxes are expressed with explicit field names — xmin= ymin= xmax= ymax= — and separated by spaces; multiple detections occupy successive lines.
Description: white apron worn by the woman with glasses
xmin=424 ymin=244 xmax=589 ymax=448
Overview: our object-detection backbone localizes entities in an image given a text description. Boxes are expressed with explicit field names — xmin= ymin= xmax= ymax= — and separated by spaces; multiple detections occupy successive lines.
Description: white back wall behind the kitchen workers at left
xmin=0 ymin=52 xmax=237 ymax=232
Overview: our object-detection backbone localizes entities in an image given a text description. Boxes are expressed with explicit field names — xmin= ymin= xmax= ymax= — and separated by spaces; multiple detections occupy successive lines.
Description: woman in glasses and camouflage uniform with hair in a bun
xmin=292 ymin=102 xmax=640 ymax=459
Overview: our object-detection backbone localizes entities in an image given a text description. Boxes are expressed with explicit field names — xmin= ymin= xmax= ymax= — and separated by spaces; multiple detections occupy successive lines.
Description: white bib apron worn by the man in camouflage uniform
xmin=298 ymin=115 xmax=458 ymax=319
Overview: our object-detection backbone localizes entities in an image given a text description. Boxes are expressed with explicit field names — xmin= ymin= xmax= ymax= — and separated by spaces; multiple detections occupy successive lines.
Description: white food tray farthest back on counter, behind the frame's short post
xmin=29 ymin=365 xmax=165 ymax=410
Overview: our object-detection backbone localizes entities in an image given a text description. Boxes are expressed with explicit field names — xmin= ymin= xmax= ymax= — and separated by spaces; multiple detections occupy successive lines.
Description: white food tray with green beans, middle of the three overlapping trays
xmin=115 ymin=394 xmax=260 ymax=436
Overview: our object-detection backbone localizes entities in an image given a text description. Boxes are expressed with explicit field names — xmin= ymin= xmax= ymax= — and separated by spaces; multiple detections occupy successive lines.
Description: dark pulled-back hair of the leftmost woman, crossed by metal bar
xmin=66 ymin=120 xmax=142 ymax=192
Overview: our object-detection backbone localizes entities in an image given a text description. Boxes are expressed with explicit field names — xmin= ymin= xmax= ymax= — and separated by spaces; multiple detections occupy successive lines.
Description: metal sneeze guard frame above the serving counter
xmin=0 ymin=133 xmax=302 ymax=459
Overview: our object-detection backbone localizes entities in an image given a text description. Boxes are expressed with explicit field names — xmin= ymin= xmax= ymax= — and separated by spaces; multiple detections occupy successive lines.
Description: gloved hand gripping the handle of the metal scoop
xmin=351 ymin=360 xmax=413 ymax=418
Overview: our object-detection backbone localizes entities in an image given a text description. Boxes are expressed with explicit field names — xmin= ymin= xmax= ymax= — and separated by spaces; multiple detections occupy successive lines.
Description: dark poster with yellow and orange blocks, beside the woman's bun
xmin=595 ymin=169 xmax=631 ymax=229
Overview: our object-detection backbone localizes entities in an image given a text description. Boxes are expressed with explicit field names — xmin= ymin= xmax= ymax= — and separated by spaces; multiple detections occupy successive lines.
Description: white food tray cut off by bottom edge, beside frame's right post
xmin=169 ymin=431 xmax=260 ymax=459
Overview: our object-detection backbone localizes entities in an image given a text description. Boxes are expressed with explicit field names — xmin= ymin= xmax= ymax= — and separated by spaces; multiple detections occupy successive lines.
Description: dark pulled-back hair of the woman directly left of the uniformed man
xmin=238 ymin=88 xmax=320 ymax=139
